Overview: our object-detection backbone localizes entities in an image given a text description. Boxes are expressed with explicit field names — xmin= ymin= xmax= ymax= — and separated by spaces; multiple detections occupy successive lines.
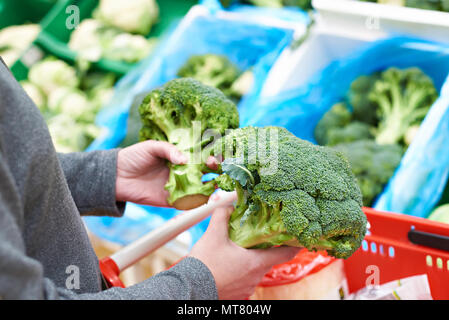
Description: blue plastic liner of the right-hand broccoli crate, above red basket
xmin=241 ymin=37 xmax=449 ymax=217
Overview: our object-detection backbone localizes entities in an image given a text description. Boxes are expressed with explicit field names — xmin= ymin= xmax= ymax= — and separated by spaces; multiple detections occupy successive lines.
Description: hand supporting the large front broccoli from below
xmin=189 ymin=207 xmax=301 ymax=300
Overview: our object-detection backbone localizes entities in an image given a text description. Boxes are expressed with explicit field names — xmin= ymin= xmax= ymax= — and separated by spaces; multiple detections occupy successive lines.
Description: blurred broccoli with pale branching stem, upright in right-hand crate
xmin=369 ymin=67 xmax=438 ymax=144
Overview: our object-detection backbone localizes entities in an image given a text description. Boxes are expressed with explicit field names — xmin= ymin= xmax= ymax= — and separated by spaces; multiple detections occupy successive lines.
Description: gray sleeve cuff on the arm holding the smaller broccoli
xmin=58 ymin=149 xmax=125 ymax=217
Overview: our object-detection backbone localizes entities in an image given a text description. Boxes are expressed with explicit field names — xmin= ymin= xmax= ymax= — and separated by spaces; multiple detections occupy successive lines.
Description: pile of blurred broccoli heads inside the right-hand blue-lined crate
xmin=314 ymin=67 xmax=438 ymax=206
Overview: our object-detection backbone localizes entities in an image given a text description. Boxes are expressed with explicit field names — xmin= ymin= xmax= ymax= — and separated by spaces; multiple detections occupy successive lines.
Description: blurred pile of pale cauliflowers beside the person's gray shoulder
xmin=21 ymin=57 xmax=116 ymax=152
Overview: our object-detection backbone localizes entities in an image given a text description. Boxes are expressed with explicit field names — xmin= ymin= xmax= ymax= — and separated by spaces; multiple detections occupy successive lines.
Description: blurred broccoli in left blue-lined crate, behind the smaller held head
xmin=177 ymin=53 xmax=244 ymax=102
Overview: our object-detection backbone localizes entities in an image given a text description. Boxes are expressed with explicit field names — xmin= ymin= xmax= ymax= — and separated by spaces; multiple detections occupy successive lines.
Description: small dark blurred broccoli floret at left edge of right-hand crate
xmin=314 ymin=103 xmax=352 ymax=145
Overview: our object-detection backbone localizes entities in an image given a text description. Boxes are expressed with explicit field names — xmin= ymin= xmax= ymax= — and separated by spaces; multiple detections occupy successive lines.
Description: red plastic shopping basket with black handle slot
xmin=345 ymin=208 xmax=449 ymax=300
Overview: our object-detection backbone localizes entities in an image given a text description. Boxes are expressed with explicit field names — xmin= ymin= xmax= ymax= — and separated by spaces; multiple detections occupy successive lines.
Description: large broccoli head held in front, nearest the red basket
xmin=214 ymin=127 xmax=367 ymax=258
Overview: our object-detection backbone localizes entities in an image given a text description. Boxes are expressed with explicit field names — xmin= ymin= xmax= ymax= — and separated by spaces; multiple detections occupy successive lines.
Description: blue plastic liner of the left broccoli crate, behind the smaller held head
xmin=86 ymin=6 xmax=294 ymax=248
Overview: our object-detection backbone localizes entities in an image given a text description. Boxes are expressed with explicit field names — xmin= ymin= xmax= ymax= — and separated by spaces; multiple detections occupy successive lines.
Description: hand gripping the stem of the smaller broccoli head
xmin=115 ymin=140 xmax=218 ymax=207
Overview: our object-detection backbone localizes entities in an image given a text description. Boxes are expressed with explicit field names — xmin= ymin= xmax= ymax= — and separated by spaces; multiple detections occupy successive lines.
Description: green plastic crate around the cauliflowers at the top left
xmin=37 ymin=0 xmax=198 ymax=75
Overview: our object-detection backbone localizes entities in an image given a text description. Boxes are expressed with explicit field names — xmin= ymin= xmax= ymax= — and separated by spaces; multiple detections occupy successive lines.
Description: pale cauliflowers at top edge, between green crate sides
xmin=68 ymin=0 xmax=159 ymax=63
